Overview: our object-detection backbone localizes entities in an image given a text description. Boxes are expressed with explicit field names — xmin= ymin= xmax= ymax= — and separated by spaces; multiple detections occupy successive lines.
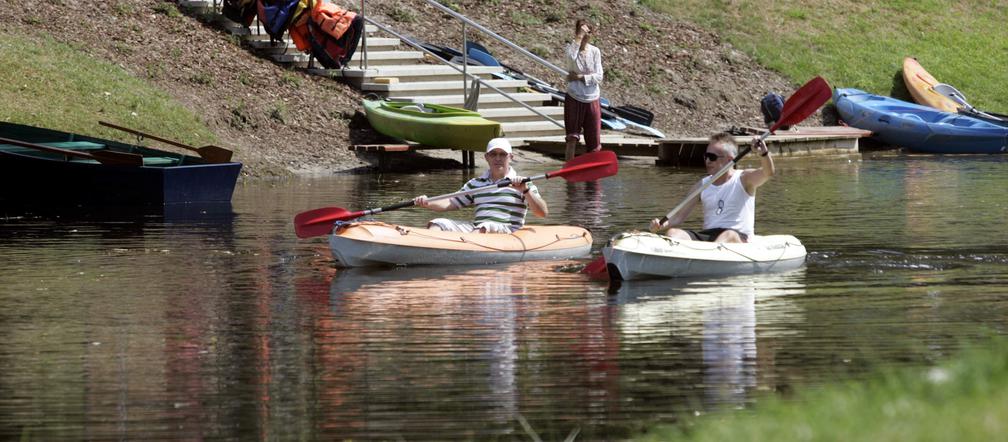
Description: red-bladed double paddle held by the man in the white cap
xmin=294 ymin=150 xmax=619 ymax=238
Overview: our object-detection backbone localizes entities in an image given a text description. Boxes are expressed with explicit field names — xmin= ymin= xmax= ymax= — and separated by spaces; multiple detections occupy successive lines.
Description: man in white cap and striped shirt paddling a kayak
xmin=413 ymin=138 xmax=549 ymax=233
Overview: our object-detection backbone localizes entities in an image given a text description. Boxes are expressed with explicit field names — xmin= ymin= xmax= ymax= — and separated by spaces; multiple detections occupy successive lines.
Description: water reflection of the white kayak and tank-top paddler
xmin=610 ymin=269 xmax=805 ymax=409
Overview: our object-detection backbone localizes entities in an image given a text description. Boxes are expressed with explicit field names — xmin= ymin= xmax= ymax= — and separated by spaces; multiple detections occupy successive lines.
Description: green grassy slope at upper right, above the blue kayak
xmin=642 ymin=0 xmax=1008 ymax=113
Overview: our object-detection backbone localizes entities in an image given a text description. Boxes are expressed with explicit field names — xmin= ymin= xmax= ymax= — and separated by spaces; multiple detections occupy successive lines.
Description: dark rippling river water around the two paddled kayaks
xmin=0 ymin=153 xmax=1008 ymax=440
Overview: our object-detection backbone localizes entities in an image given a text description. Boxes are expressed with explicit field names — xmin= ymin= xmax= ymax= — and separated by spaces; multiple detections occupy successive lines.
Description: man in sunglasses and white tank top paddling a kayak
xmin=651 ymin=132 xmax=775 ymax=242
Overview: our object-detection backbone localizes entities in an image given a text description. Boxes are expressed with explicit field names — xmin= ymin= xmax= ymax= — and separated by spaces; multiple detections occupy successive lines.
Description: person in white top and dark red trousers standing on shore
xmin=563 ymin=19 xmax=603 ymax=160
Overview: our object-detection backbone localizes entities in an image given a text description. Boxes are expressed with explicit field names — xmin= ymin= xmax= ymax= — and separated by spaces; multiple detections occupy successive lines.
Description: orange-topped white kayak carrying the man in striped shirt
xmin=329 ymin=222 xmax=592 ymax=267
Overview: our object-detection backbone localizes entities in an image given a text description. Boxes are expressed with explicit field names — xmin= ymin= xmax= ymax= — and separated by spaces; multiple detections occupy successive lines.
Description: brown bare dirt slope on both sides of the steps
xmin=0 ymin=0 xmax=818 ymax=177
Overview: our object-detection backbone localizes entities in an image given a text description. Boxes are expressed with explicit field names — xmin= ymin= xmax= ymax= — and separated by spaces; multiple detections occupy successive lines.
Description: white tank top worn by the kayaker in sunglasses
xmin=700 ymin=172 xmax=756 ymax=236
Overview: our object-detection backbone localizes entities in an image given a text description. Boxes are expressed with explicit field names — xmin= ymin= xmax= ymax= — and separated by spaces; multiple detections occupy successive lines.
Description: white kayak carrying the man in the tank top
xmin=602 ymin=232 xmax=805 ymax=281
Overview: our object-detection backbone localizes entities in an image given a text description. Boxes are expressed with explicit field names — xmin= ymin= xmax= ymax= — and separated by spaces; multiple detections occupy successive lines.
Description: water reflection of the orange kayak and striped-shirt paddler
xmin=316 ymin=262 xmax=619 ymax=439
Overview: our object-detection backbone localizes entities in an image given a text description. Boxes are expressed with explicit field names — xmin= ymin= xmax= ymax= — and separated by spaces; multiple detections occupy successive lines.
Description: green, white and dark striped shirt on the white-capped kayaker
xmin=452 ymin=168 xmax=539 ymax=230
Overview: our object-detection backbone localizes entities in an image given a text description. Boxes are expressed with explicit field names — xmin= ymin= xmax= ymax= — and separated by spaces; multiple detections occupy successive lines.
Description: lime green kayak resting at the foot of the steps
xmin=364 ymin=100 xmax=504 ymax=150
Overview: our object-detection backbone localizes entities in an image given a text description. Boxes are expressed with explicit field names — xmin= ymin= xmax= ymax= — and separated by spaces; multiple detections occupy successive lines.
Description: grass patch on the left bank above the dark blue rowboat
xmin=0 ymin=33 xmax=217 ymax=145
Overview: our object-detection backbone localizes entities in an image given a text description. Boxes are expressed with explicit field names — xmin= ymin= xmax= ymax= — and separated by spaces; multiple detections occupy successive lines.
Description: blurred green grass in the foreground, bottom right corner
xmin=638 ymin=338 xmax=1008 ymax=441
